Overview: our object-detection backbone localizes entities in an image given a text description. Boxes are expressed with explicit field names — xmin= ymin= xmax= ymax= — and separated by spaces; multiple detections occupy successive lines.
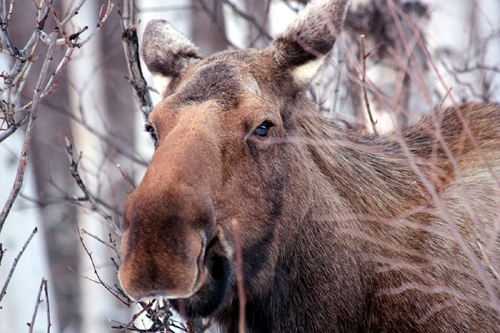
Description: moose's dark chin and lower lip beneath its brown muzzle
xmin=170 ymin=240 xmax=232 ymax=318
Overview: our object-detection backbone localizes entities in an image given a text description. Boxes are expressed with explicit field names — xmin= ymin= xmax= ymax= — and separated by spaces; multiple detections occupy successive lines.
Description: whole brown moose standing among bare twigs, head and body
xmin=118 ymin=0 xmax=500 ymax=332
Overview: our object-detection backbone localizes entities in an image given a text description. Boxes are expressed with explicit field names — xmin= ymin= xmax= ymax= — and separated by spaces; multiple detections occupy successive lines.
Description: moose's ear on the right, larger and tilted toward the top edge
xmin=270 ymin=0 xmax=349 ymax=85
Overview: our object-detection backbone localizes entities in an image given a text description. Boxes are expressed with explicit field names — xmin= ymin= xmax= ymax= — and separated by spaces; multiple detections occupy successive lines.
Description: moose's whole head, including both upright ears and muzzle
xmin=119 ymin=1 xmax=346 ymax=317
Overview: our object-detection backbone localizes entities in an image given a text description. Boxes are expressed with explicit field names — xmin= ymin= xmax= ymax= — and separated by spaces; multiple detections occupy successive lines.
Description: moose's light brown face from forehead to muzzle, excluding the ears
xmin=119 ymin=52 xmax=284 ymax=313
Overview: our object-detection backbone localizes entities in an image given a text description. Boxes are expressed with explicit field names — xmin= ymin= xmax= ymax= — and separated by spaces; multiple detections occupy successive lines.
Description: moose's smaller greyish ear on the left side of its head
xmin=141 ymin=20 xmax=200 ymax=97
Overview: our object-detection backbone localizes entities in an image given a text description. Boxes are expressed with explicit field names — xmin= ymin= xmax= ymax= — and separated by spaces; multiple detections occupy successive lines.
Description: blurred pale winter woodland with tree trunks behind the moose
xmin=0 ymin=0 xmax=500 ymax=333
